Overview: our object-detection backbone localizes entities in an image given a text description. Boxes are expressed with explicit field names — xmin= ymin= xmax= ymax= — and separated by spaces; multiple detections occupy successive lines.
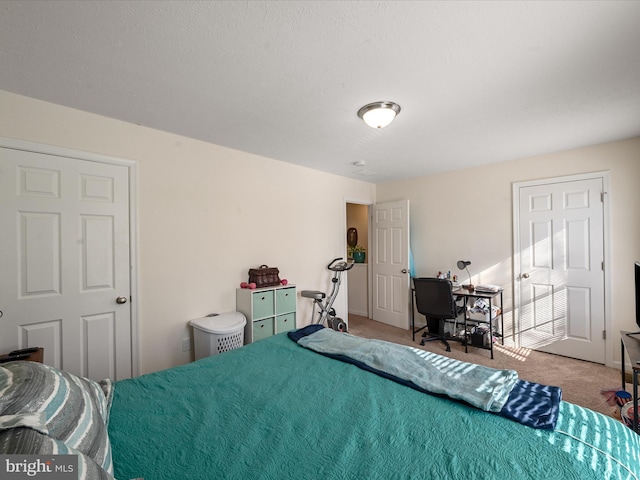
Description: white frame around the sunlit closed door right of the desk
xmin=511 ymin=171 xmax=617 ymax=368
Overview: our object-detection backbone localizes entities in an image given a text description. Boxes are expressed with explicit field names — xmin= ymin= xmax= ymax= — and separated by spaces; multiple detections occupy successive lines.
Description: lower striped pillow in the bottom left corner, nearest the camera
xmin=0 ymin=428 xmax=114 ymax=480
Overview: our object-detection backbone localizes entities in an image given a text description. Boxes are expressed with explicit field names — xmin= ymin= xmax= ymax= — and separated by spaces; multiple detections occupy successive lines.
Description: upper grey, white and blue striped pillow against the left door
xmin=0 ymin=361 xmax=113 ymax=474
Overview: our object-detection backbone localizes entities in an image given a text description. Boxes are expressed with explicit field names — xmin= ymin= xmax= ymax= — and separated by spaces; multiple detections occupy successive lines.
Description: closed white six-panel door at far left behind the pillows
xmin=0 ymin=144 xmax=132 ymax=379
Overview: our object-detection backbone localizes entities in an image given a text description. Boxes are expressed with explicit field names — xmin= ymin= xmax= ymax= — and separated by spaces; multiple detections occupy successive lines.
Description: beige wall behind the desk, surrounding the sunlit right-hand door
xmin=376 ymin=138 xmax=640 ymax=365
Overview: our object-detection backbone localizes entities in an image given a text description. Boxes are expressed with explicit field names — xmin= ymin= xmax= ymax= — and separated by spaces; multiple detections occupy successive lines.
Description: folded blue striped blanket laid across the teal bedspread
xmin=288 ymin=325 xmax=562 ymax=430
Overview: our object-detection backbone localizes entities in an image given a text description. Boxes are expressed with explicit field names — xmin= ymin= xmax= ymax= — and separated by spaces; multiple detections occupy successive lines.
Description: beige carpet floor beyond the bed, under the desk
xmin=349 ymin=315 xmax=631 ymax=416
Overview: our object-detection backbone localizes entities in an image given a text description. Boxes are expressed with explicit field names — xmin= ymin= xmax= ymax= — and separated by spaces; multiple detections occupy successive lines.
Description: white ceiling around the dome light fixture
xmin=0 ymin=0 xmax=640 ymax=183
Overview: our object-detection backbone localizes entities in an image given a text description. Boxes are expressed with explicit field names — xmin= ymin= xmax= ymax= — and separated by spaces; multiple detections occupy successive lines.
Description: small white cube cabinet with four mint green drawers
xmin=236 ymin=285 xmax=296 ymax=344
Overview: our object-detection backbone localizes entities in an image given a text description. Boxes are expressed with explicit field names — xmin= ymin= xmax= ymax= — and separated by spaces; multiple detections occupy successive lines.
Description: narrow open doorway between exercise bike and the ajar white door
xmin=345 ymin=202 xmax=370 ymax=318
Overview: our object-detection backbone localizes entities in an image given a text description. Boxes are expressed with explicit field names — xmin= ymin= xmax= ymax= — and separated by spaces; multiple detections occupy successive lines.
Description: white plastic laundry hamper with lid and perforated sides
xmin=191 ymin=312 xmax=247 ymax=360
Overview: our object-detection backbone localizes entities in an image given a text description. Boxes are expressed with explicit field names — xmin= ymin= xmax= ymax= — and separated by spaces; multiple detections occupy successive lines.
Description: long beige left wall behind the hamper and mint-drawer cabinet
xmin=0 ymin=91 xmax=375 ymax=373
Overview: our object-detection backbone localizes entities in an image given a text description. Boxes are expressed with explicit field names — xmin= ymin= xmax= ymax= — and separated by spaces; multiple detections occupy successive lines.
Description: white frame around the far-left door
xmin=0 ymin=136 xmax=140 ymax=377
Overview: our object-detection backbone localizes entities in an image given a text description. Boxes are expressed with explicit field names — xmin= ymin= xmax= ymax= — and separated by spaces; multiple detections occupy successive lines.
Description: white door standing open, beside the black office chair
xmin=369 ymin=200 xmax=410 ymax=329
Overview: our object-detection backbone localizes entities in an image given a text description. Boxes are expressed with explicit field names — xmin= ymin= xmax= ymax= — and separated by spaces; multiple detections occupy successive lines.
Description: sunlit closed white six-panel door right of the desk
xmin=514 ymin=175 xmax=606 ymax=363
